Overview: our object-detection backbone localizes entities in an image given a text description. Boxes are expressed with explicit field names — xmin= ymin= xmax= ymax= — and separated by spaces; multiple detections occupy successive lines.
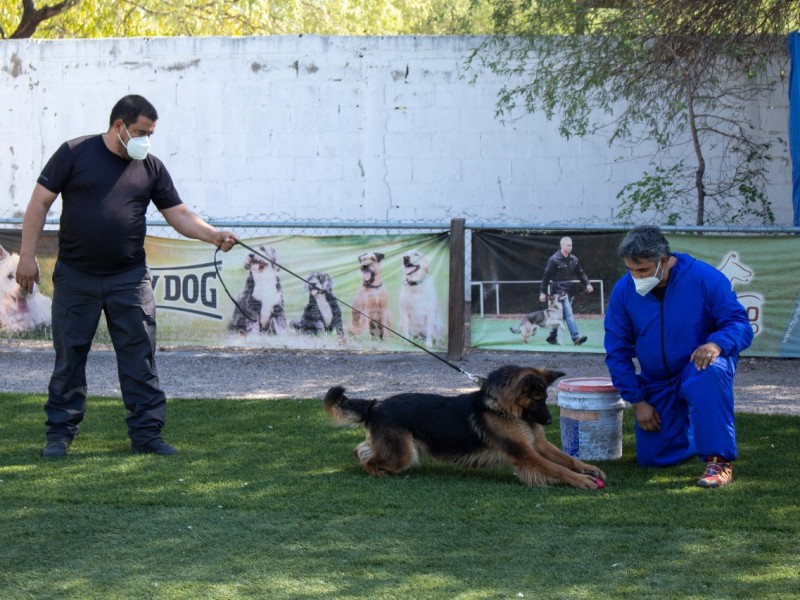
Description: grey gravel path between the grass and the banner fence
xmin=0 ymin=340 xmax=800 ymax=415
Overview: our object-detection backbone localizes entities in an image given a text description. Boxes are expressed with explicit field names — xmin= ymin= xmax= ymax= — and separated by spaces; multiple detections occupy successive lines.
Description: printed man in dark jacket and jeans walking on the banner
xmin=539 ymin=236 xmax=594 ymax=346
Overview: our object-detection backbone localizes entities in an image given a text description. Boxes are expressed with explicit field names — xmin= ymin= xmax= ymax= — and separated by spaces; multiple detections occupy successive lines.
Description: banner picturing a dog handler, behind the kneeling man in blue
xmin=471 ymin=231 xmax=800 ymax=357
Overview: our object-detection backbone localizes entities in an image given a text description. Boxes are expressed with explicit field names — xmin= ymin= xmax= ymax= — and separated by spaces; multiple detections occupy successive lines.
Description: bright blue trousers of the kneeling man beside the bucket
xmin=636 ymin=356 xmax=737 ymax=467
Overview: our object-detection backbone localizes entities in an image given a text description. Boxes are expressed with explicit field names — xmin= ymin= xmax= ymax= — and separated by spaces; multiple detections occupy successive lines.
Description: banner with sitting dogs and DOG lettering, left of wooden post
xmin=0 ymin=232 xmax=449 ymax=351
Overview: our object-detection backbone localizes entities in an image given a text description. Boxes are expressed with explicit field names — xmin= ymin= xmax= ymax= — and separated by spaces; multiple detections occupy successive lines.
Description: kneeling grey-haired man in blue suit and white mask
xmin=605 ymin=226 xmax=753 ymax=488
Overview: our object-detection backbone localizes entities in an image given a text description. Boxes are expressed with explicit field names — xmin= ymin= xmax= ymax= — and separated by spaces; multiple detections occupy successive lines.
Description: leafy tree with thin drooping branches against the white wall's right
xmin=469 ymin=0 xmax=800 ymax=225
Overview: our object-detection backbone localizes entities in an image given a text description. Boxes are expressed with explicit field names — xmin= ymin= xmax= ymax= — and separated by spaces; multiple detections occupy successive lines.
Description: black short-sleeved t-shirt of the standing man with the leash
xmin=38 ymin=135 xmax=181 ymax=275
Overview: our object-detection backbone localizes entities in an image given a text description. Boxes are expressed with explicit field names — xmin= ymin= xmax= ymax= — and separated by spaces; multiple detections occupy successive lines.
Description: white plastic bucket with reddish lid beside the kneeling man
xmin=558 ymin=377 xmax=625 ymax=460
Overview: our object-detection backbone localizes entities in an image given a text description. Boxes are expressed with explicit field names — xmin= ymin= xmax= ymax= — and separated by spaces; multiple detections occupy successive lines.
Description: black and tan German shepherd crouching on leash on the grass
xmin=323 ymin=365 xmax=606 ymax=490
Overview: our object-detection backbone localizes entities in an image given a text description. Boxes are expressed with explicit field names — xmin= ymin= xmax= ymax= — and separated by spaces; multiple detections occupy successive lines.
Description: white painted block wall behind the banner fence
xmin=0 ymin=36 xmax=792 ymax=225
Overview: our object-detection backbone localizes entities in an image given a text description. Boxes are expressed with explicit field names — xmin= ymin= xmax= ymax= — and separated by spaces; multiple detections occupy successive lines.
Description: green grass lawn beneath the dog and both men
xmin=0 ymin=394 xmax=800 ymax=599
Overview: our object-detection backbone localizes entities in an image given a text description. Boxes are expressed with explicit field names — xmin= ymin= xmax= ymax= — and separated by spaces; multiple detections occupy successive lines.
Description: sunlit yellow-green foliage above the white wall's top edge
xmin=0 ymin=0 xmax=490 ymax=38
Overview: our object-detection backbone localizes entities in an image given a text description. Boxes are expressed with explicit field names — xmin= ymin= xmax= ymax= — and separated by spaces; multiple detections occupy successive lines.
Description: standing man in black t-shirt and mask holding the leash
xmin=17 ymin=95 xmax=236 ymax=458
